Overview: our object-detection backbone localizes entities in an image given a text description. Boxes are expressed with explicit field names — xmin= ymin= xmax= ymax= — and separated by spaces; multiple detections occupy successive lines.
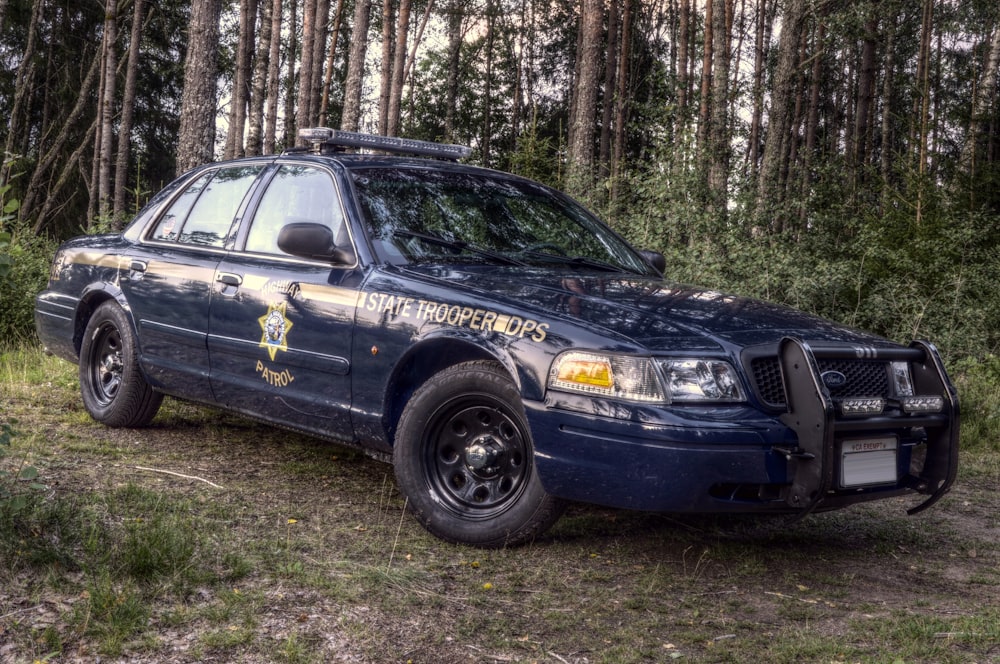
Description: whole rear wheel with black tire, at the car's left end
xmin=80 ymin=300 xmax=163 ymax=427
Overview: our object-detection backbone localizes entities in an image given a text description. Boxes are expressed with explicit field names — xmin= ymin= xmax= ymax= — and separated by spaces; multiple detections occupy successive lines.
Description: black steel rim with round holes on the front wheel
xmin=424 ymin=395 xmax=530 ymax=519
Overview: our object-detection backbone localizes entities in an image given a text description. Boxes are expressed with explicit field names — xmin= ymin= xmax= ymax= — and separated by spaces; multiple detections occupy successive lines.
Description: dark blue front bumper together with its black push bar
xmin=525 ymin=339 xmax=959 ymax=515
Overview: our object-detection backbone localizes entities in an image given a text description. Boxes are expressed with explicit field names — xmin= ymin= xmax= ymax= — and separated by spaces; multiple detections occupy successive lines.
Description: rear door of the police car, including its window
xmin=121 ymin=164 xmax=264 ymax=401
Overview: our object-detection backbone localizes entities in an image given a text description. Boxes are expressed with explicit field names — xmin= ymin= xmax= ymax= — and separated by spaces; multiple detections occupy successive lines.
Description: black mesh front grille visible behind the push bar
xmin=750 ymin=357 xmax=890 ymax=408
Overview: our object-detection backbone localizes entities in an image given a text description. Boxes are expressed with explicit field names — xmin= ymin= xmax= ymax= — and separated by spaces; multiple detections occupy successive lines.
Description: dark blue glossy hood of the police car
xmin=402 ymin=266 xmax=890 ymax=351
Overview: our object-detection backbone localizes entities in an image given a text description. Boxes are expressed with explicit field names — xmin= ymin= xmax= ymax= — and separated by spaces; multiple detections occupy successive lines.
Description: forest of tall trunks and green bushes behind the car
xmin=0 ymin=0 xmax=1000 ymax=364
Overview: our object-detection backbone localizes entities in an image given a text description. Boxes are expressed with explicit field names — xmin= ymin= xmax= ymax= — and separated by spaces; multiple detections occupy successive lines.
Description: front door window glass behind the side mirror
xmin=246 ymin=164 xmax=350 ymax=254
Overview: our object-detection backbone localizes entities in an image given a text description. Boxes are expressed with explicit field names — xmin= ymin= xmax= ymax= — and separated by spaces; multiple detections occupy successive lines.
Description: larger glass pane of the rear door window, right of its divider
xmin=180 ymin=165 xmax=264 ymax=247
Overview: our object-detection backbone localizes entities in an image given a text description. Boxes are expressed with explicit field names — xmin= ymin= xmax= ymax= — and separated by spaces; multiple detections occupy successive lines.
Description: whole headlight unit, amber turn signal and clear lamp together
xmin=549 ymin=351 xmax=744 ymax=403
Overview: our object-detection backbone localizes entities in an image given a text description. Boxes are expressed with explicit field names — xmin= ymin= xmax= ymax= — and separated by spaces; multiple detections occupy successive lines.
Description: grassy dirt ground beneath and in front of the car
xmin=0 ymin=350 xmax=1000 ymax=663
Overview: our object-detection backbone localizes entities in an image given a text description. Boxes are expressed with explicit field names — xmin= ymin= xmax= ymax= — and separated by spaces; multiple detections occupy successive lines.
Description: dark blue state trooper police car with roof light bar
xmin=35 ymin=128 xmax=959 ymax=547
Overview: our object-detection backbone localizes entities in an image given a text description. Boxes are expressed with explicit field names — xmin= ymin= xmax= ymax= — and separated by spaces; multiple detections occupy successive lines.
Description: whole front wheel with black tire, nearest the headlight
xmin=393 ymin=362 xmax=565 ymax=548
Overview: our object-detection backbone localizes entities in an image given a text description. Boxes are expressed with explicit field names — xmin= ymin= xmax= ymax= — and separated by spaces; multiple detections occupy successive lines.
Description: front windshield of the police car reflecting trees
xmin=353 ymin=168 xmax=651 ymax=274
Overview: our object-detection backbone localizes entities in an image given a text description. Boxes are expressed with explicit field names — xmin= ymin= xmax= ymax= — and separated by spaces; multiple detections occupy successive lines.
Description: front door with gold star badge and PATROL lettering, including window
xmin=209 ymin=162 xmax=362 ymax=440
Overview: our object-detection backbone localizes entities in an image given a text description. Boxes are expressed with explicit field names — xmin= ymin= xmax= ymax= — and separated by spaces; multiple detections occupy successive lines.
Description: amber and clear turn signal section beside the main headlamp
xmin=549 ymin=351 xmax=664 ymax=402
